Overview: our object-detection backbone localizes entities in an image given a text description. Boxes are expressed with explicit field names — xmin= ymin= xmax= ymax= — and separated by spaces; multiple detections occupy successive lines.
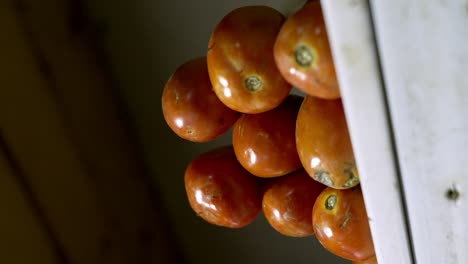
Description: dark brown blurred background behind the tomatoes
xmin=0 ymin=0 xmax=349 ymax=264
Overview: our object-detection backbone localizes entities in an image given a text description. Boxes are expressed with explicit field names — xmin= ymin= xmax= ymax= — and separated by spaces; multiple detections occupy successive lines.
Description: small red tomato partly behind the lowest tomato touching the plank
xmin=263 ymin=169 xmax=325 ymax=237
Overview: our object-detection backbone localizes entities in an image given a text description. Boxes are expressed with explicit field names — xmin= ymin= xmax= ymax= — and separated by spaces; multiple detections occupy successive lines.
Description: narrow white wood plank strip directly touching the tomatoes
xmin=322 ymin=0 xmax=411 ymax=264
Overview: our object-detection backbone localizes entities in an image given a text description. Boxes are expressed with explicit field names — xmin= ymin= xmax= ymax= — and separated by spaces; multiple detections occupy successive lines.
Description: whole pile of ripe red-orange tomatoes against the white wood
xmin=162 ymin=1 xmax=376 ymax=263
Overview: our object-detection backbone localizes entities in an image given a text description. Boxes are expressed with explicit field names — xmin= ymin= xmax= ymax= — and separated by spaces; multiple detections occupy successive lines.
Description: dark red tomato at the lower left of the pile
xmin=185 ymin=146 xmax=262 ymax=228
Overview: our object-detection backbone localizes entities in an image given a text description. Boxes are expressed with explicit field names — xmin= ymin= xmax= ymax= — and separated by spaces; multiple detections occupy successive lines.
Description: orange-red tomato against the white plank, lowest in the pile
xmin=312 ymin=187 xmax=375 ymax=261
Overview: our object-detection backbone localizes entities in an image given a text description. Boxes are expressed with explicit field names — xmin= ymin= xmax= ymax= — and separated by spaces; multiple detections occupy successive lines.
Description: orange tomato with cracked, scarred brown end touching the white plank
xmin=296 ymin=96 xmax=359 ymax=189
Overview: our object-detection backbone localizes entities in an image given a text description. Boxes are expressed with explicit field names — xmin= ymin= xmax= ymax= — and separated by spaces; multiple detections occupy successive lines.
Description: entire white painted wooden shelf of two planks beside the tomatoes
xmin=322 ymin=0 xmax=468 ymax=264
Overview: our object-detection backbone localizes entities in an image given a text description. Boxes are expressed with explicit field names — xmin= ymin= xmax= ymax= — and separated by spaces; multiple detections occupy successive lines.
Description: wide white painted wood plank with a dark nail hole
xmin=372 ymin=0 xmax=468 ymax=264
